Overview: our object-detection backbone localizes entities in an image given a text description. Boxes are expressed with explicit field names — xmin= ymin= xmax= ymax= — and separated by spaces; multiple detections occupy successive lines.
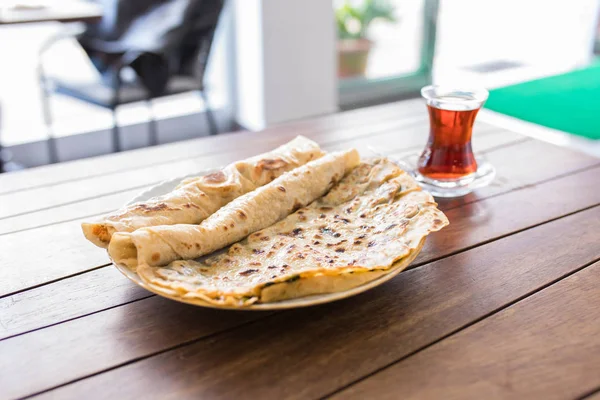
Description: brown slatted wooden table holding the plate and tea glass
xmin=0 ymin=97 xmax=600 ymax=399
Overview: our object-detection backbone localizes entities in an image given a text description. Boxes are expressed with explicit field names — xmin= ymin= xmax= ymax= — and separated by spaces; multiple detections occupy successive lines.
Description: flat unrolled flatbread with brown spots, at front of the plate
xmin=137 ymin=159 xmax=448 ymax=307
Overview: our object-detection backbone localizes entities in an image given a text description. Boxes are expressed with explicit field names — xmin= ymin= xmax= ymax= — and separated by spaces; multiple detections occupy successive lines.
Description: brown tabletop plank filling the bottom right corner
xmin=334 ymin=260 xmax=600 ymax=399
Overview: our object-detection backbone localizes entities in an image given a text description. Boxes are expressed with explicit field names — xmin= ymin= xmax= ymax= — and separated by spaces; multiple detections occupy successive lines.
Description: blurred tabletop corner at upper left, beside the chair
xmin=0 ymin=1 xmax=102 ymax=25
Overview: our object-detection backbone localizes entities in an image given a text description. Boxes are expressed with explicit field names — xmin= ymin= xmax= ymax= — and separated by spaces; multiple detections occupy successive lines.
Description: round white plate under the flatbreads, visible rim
xmin=113 ymin=169 xmax=425 ymax=310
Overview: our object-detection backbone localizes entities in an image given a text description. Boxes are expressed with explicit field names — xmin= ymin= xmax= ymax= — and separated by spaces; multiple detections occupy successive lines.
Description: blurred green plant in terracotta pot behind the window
xmin=335 ymin=0 xmax=397 ymax=78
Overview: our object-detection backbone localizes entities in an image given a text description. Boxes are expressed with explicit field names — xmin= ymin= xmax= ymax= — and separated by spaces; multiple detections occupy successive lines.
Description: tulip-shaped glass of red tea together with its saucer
xmin=406 ymin=86 xmax=496 ymax=197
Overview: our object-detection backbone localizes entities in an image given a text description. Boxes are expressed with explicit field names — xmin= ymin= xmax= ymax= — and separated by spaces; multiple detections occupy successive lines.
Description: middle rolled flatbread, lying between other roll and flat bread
xmin=108 ymin=150 xmax=360 ymax=268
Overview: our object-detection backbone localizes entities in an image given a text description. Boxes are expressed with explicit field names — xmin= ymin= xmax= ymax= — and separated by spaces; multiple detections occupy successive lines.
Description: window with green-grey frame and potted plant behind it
xmin=334 ymin=0 xmax=438 ymax=108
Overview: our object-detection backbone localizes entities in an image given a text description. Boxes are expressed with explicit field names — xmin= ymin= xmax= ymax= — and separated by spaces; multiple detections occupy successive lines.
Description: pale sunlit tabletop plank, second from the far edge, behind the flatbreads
xmin=0 ymin=114 xmax=436 ymax=219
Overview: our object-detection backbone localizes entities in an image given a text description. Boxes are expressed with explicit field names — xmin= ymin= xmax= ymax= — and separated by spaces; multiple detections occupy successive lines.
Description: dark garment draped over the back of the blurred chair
xmin=80 ymin=0 xmax=223 ymax=97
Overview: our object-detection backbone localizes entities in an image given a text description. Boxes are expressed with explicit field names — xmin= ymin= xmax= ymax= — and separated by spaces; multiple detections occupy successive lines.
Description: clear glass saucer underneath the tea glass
xmin=392 ymin=153 xmax=496 ymax=197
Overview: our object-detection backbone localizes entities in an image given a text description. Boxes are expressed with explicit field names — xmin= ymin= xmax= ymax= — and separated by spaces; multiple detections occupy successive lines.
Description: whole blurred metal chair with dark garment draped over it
xmin=38 ymin=0 xmax=223 ymax=163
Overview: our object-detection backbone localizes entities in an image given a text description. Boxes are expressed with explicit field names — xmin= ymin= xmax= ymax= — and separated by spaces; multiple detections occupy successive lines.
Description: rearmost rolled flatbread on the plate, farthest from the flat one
xmin=81 ymin=136 xmax=324 ymax=248
